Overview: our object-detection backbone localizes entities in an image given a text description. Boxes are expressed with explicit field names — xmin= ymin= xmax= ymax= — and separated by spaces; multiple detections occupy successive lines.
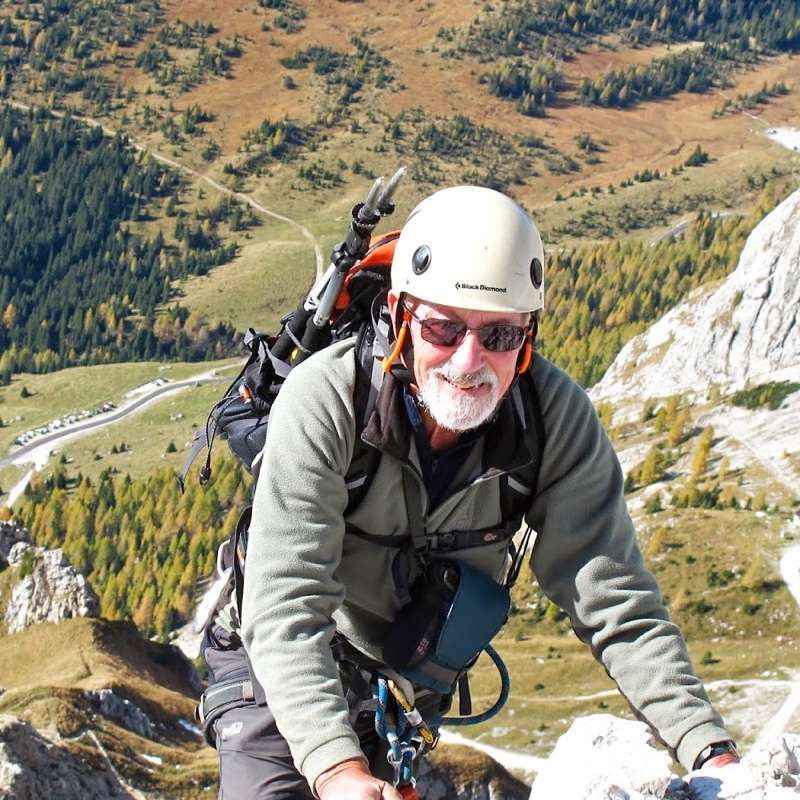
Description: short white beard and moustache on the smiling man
xmin=417 ymin=361 xmax=502 ymax=433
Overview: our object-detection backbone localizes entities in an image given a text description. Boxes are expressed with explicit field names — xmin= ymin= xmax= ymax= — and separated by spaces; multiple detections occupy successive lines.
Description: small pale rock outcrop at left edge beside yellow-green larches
xmin=4 ymin=541 xmax=100 ymax=633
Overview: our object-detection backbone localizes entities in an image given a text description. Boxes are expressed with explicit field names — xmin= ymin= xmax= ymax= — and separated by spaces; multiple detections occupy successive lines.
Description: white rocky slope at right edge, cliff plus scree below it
xmin=590 ymin=191 xmax=800 ymax=506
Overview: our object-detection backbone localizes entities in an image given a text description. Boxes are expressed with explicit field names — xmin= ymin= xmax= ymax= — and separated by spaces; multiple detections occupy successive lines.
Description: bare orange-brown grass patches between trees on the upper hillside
xmin=106 ymin=0 xmax=800 ymax=216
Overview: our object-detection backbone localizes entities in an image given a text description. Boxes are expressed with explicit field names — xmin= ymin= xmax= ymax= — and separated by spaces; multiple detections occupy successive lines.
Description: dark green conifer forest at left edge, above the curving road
xmin=0 ymin=108 xmax=237 ymax=381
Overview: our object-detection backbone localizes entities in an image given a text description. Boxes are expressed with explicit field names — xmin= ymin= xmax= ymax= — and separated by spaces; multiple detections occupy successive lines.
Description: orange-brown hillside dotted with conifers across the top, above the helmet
xmin=0 ymin=0 xmax=800 ymax=241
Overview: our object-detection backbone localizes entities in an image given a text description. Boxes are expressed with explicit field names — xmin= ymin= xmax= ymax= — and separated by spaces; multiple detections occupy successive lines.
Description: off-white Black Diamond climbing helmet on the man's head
xmin=392 ymin=186 xmax=544 ymax=312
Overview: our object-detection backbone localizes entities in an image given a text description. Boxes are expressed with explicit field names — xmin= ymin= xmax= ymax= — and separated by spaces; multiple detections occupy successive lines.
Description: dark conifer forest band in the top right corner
xmin=462 ymin=0 xmax=800 ymax=117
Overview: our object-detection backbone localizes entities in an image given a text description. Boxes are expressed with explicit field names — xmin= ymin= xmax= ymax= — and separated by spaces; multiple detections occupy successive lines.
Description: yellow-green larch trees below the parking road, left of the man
xmin=8 ymin=457 xmax=247 ymax=637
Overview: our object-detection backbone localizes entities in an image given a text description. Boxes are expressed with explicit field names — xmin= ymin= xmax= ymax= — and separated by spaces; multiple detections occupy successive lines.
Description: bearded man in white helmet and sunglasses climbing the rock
xmin=202 ymin=186 xmax=737 ymax=800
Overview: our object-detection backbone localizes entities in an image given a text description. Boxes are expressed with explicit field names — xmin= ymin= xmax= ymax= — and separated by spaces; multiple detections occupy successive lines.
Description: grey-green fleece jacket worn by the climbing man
xmin=242 ymin=341 xmax=730 ymax=786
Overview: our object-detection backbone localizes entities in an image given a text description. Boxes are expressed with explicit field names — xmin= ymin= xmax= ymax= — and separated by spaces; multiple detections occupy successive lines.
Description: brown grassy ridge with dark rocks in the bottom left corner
xmin=0 ymin=618 xmax=216 ymax=800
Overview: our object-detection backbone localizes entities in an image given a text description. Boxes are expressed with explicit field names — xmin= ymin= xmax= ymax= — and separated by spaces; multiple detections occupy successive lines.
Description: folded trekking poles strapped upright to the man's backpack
xmin=272 ymin=167 xmax=406 ymax=365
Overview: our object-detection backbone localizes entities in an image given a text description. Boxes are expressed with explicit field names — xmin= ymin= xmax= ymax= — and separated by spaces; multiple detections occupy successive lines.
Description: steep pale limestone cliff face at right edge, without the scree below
xmin=591 ymin=191 xmax=800 ymax=403
